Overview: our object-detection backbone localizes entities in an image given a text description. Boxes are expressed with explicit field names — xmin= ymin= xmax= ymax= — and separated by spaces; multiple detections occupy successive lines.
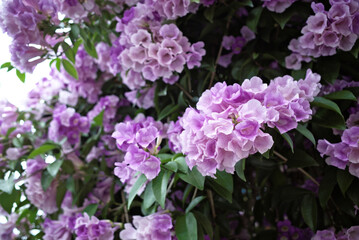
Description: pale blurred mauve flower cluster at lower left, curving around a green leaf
xmin=25 ymin=158 xmax=58 ymax=214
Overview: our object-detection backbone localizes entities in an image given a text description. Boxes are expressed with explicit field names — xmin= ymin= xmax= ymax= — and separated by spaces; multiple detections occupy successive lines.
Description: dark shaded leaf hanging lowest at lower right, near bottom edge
xmin=301 ymin=194 xmax=317 ymax=232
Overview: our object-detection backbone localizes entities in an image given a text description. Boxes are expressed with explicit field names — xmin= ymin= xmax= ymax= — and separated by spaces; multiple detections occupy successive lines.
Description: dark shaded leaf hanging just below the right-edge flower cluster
xmin=318 ymin=167 xmax=337 ymax=208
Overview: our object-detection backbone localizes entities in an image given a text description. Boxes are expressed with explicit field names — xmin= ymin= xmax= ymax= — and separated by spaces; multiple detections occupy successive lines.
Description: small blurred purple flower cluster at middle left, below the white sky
xmin=48 ymin=105 xmax=90 ymax=145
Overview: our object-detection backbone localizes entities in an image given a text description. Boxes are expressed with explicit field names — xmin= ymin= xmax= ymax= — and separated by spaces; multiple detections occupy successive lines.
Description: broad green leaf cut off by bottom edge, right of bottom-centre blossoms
xmin=175 ymin=213 xmax=197 ymax=240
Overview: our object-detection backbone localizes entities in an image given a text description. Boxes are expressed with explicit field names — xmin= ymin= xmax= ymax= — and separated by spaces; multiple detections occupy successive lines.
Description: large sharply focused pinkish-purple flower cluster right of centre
xmin=180 ymin=70 xmax=320 ymax=176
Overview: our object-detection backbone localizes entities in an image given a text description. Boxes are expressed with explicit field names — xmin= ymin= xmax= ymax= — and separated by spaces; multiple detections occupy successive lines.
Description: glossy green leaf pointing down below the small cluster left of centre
xmin=152 ymin=169 xmax=171 ymax=209
